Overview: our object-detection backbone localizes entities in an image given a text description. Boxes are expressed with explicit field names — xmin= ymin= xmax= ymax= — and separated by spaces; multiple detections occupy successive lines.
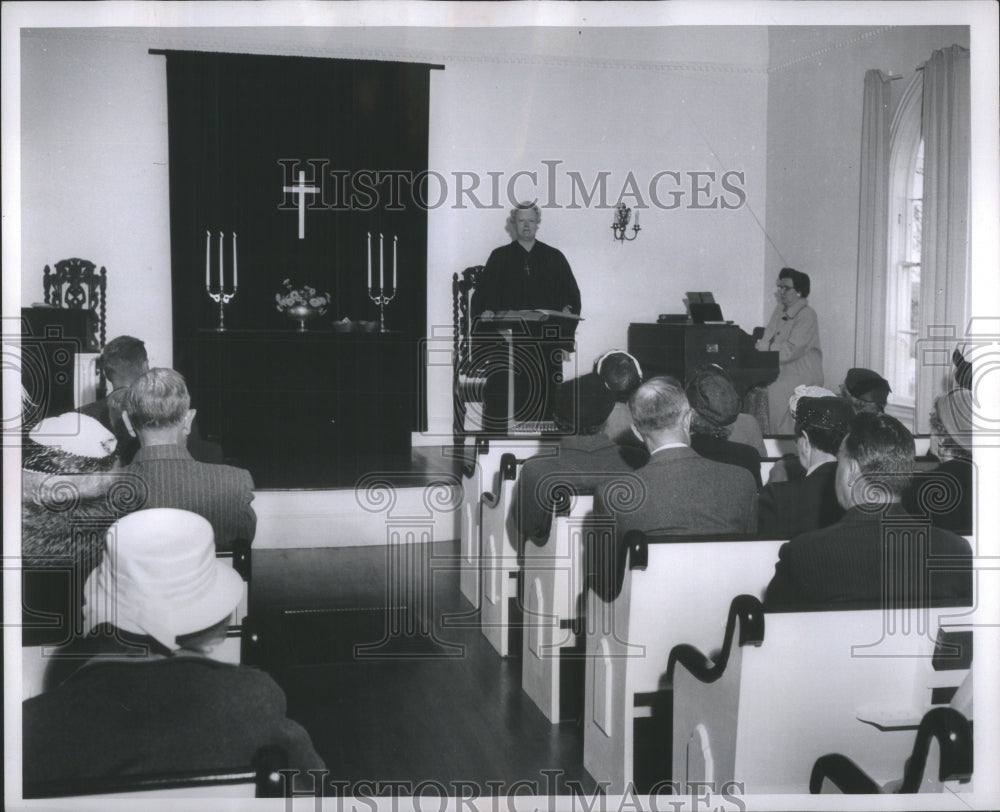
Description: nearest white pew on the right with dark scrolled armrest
xmin=667 ymin=595 xmax=972 ymax=795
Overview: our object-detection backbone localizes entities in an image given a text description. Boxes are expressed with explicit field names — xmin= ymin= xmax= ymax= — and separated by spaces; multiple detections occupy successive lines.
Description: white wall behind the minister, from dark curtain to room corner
xmin=428 ymin=56 xmax=766 ymax=434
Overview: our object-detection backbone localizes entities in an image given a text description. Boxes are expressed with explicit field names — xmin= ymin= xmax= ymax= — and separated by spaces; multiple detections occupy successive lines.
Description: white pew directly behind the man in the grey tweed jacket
xmin=583 ymin=533 xmax=784 ymax=793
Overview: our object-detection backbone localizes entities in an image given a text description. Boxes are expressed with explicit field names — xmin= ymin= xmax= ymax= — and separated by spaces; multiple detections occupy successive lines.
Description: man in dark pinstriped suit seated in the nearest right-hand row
xmin=764 ymin=412 xmax=972 ymax=610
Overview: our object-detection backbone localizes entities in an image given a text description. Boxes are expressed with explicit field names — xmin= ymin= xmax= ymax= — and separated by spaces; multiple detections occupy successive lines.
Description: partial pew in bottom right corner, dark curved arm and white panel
xmin=809 ymin=708 xmax=973 ymax=795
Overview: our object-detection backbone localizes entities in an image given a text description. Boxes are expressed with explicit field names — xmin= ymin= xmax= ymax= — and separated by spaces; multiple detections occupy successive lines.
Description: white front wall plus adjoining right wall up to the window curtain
xmin=21 ymin=28 xmax=968 ymax=440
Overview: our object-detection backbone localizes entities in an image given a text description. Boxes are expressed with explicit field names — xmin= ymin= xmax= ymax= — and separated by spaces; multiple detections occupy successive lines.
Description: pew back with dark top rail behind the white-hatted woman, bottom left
xmin=22 ymin=745 xmax=292 ymax=809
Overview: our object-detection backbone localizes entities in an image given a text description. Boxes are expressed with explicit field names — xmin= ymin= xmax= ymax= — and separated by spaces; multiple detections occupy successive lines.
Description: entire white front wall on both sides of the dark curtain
xmin=21 ymin=28 xmax=767 ymax=440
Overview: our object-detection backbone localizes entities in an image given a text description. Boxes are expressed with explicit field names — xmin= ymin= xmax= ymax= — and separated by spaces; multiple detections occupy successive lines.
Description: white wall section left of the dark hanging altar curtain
xmin=21 ymin=35 xmax=173 ymax=366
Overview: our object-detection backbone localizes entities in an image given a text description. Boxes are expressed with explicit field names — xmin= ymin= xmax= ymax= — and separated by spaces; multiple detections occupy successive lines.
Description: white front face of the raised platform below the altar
xmin=253 ymin=488 xmax=461 ymax=550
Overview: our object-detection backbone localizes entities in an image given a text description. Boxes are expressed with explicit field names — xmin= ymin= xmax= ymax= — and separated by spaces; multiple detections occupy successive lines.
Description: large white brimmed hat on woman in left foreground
xmin=83 ymin=508 xmax=244 ymax=650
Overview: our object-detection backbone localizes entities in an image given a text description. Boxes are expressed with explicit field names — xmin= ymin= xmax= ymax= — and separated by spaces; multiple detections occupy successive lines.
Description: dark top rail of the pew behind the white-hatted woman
xmin=22 ymin=744 xmax=292 ymax=799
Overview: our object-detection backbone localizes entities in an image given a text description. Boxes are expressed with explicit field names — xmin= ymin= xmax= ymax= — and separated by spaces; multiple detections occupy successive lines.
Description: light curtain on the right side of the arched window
xmin=916 ymin=45 xmax=970 ymax=433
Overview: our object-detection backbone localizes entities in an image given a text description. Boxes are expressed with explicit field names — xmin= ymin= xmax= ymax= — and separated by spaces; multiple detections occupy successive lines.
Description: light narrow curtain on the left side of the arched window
xmin=854 ymin=70 xmax=892 ymax=369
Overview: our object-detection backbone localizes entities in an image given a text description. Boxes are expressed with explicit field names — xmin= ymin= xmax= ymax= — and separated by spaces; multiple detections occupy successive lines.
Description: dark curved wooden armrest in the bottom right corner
xmin=809 ymin=707 xmax=974 ymax=795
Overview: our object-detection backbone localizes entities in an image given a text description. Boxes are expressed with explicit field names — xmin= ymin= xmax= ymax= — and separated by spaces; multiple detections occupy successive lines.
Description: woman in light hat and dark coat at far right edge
xmin=904 ymin=388 xmax=974 ymax=536
